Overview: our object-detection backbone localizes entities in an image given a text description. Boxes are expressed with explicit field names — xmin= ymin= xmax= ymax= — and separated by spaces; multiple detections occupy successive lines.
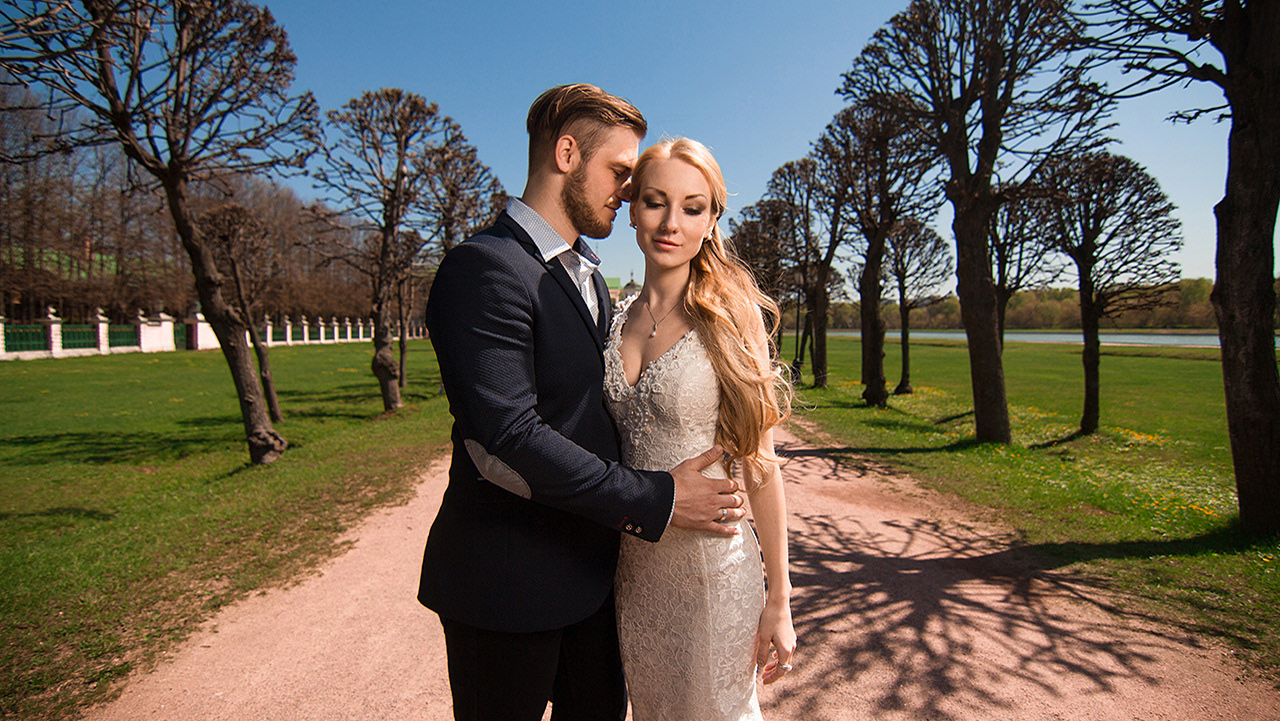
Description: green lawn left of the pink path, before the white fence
xmin=0 ymin=342 xmax=448 ymax=718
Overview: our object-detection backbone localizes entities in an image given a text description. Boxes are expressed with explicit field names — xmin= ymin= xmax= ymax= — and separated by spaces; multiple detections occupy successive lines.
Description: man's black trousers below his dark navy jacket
xmin=440 ymin=593 xmax=627 ymax=721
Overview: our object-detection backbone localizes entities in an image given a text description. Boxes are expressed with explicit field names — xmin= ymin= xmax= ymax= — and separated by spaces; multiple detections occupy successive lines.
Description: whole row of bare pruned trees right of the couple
xmin=735 ymin=0 xmax=1280 ymax=533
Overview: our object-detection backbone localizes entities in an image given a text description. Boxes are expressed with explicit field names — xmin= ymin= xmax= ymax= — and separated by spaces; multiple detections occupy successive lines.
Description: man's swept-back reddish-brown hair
xmin=526 ymin=83 xmax=649 ymax=173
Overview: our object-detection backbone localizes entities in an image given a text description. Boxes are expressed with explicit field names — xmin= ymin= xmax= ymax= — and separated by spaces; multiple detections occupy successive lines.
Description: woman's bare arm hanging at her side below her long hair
xmin=742 ymin=429 xmax=796 ymax=684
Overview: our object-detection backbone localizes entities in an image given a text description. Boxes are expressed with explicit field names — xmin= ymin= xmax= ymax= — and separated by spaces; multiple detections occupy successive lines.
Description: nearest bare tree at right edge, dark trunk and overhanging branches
xmin=1087 ymin=0 xmax=1280 ymax=534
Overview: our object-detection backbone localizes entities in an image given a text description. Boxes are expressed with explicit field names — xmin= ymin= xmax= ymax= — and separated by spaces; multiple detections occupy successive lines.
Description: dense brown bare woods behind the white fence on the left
xmin=0 ymin=86 xmax=369 ymax=323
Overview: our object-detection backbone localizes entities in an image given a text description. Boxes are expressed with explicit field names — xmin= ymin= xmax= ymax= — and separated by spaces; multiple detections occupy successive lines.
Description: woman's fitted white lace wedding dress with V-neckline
xmin=604 ymin=298 xmax=764 ymax=721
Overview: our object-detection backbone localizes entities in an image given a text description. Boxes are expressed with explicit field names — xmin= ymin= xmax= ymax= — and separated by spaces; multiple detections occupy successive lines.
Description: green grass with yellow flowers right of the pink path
xmin=785 ymin=338 xmax=1280 ymax=679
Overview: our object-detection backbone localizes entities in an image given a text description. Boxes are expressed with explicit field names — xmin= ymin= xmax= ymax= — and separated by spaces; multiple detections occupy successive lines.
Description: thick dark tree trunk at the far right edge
xmin=1210 ymin=67 xmax=1280 ymax=535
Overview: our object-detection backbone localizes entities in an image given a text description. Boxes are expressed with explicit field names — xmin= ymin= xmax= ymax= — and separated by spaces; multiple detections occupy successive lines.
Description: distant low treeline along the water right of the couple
xmin=782 ymin=278 xmax=1254 ymax=330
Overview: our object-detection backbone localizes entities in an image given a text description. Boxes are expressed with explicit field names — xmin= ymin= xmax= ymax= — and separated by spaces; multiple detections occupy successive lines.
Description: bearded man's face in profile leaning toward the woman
xmin=561 ymin=126 xmax=640 ymax=238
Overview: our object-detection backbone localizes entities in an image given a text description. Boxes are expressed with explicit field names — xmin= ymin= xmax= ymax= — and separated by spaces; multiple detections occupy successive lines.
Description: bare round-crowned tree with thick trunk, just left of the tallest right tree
xmin=814 ymin=99 xmax=941 ymax=407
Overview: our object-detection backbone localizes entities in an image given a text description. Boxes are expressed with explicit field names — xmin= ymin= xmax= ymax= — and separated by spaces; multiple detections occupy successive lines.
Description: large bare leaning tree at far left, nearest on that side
xmin=6 ymin=0 xmax=316 ymax=464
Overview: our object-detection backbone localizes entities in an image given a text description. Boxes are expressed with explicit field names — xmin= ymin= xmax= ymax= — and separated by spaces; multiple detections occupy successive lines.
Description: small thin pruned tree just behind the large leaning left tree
xmin=197 ymin=202 xmax=284 ymax=423
